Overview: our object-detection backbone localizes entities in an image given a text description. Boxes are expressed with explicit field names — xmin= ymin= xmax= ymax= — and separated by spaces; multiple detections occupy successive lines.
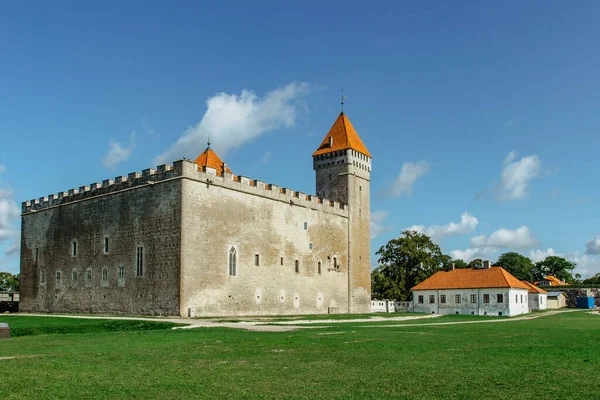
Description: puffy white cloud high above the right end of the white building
xmin=500 ymin=151 xmax=541 ymax=201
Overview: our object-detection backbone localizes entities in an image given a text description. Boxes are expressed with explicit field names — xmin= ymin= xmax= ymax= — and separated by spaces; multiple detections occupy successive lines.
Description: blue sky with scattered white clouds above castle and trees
xmin=0 ymin=1 xmax=600 ymax=276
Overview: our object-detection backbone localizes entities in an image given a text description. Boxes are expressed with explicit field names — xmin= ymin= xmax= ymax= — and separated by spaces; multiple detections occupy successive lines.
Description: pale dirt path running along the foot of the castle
xmin=7 ymin=310 xmax=579 ymax=332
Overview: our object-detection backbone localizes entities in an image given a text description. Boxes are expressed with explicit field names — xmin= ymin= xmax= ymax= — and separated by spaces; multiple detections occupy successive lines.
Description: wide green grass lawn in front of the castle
xmin=0 ymin=312 xmax=600 ymax=399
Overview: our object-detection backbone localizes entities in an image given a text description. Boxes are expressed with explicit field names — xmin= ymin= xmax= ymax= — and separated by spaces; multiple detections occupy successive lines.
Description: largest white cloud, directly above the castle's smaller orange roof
xmin=154 ymin=82 xmax=310 ymax=164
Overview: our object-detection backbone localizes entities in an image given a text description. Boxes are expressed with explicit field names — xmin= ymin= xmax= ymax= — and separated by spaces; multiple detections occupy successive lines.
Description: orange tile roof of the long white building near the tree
xmin=411 ymin=267 xmax=529 ymax=290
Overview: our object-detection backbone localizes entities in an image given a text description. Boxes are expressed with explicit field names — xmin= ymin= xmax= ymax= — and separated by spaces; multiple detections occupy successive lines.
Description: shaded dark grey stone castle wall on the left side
xmin=20 ymin=179 xmax=181 ymax=315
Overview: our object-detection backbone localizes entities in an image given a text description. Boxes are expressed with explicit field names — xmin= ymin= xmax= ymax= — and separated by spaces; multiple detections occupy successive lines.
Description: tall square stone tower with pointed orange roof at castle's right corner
xmin=313 ymin=112 xmax=371 ymax=313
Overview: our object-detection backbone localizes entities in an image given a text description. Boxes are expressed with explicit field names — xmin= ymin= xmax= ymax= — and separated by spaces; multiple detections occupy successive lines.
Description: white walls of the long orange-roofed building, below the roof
xmin=413 ymin=288 xmax=529 ymax=316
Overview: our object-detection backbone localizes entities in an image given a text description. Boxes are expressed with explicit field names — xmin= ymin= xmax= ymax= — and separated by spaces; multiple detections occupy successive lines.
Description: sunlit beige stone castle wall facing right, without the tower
xmin=180 ymin=163 xmax=348 ymax=316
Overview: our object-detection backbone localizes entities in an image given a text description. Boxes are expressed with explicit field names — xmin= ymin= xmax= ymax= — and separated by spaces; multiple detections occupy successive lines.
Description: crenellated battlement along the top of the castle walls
xmin=21 ymin=160 xmax=348 ymax=216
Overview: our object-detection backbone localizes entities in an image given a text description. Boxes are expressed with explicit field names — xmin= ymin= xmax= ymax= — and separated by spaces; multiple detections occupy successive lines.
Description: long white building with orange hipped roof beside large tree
xmin=412 ymin=261 xmax=529 ymax=316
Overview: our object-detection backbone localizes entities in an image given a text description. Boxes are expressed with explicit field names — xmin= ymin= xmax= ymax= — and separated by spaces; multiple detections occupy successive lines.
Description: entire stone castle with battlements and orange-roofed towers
xmin=20 ymin=112 xmax=371 ymax=317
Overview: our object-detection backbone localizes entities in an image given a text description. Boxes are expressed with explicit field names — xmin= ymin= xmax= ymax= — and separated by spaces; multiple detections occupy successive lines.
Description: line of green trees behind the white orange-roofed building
xmin=371 ymin=230 xmax=580 ymax=301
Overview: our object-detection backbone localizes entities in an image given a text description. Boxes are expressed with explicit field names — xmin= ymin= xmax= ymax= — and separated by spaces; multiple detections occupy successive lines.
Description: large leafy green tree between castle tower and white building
xmin=371 ymin=230 xmax=450 ymax=300
